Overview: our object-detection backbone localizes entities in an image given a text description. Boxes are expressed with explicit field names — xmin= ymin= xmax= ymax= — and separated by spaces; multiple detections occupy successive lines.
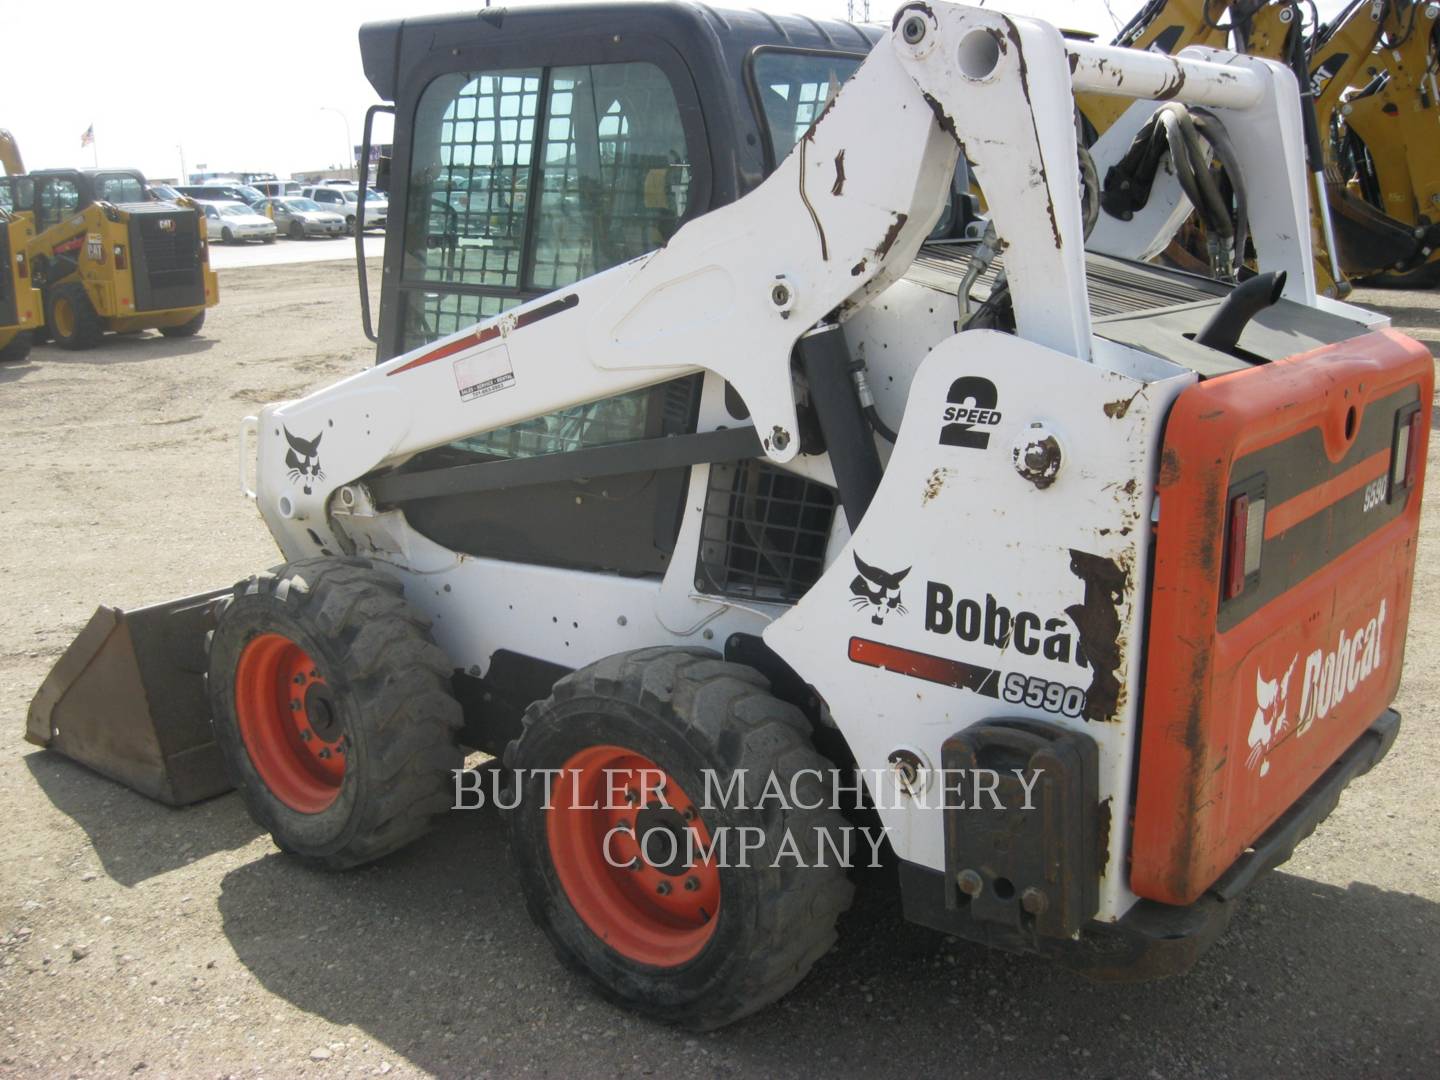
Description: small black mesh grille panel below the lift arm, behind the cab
xmin=696 ymin=461 xmax=835 ymax=602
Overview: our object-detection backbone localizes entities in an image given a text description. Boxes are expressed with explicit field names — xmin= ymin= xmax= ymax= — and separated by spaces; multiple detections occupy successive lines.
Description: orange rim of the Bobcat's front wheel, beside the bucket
xmin=235 ymin=634 xmax=350 ymax=814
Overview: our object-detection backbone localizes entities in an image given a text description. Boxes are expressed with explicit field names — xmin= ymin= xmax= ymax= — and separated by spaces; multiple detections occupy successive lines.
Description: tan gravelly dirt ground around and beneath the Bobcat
xmin=0 ymin=262 xmax=1440 ymax=1079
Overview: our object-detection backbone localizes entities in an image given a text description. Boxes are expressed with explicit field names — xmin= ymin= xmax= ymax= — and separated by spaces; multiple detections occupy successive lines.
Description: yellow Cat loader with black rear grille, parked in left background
xmin=2 ymin=150 xmax=220 ymax=348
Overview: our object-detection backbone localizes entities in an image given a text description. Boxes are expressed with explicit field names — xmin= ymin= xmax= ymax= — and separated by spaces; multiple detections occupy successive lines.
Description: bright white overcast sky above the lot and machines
xmin=0 ymin=0 xmax=1339 ymax=179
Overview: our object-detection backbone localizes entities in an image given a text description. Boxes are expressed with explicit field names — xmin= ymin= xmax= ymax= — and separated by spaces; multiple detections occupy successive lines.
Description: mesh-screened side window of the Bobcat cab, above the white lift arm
xmin=379 ymin=35 xmax=710 ymax=360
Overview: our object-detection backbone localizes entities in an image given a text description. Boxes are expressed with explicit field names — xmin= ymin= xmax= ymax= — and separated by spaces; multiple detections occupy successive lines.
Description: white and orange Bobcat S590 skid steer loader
xmin=27 ymin=1 xmax=1433 ymax=1027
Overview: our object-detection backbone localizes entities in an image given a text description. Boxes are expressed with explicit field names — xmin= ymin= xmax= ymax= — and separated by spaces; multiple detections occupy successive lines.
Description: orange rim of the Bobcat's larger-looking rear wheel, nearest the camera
xmin=546 ymin=746 xmax=720 ymax=968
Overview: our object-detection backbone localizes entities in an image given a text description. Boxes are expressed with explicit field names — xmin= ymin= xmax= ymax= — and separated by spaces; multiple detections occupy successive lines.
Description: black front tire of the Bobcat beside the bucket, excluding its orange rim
xmin=206 ymin=557 xmax=464 ymax=870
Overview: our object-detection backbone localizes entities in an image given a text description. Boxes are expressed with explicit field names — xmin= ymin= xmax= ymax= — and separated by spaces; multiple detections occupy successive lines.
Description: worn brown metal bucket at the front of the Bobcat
xmin=24 ymin=590 xmax=230 ymax=806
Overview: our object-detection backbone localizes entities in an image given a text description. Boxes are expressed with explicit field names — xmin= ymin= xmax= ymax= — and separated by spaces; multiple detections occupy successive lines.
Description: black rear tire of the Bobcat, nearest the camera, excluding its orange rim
xmin=505 ymin=647 xmax=846 ymax=1030
